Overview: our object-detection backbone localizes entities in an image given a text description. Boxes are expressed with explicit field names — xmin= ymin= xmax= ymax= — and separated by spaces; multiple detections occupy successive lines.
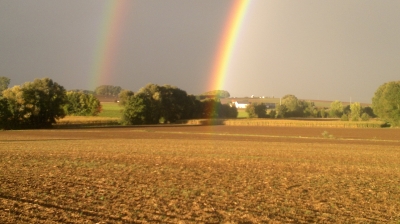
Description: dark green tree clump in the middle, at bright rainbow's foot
xmin=122 ymin=84 xmax=238 ymax=124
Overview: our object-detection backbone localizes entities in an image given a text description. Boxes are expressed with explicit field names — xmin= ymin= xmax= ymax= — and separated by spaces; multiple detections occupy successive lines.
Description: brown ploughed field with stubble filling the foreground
xmin=0 ymin=125 xmax=400 ymax=223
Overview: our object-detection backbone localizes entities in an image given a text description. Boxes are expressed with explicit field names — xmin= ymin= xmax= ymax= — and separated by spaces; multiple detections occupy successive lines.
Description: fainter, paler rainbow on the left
xmin=89 ymin=0 xmax=129 ymax=89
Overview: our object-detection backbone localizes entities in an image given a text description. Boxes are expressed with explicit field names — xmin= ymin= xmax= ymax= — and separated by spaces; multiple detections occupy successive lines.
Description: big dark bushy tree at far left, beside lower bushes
xmin=3 ymin=78 xmax=66 ymax=128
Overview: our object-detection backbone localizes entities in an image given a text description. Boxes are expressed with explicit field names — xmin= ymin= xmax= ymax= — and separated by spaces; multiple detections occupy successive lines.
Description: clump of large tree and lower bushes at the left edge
xmin=0 ymin=77 xmax=101 ymax=129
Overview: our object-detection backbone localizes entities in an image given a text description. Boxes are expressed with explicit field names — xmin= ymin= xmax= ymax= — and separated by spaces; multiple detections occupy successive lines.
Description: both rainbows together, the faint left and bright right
xmin=89 ymin=0 xmax=251 ymax=90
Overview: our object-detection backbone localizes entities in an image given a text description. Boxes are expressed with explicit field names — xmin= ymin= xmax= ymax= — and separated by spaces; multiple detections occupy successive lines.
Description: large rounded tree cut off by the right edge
xmin=372 ymin=81 xmax=400 ymax=126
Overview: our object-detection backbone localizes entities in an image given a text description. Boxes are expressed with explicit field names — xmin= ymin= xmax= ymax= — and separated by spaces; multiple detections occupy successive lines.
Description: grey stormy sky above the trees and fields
xmin=0 ymin=0 xmax=400 ymax=103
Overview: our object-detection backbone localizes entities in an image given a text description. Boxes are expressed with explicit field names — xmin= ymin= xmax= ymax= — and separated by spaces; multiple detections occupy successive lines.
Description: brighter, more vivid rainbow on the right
xmin=208 ymin=0 xmax=250 ymax=90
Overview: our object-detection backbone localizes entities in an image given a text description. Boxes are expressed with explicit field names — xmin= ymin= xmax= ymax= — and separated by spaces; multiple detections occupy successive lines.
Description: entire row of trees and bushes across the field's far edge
xmin=0 ymin=77 xmax=400 ymax=129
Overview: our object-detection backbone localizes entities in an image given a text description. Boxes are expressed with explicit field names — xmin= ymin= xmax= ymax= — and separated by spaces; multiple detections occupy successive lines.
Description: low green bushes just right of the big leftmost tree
xmin=64 ymin=91 xmax=101 ymax=116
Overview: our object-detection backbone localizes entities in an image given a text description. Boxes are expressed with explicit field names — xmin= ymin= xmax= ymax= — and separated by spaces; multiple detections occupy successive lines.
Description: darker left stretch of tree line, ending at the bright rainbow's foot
xmin=0 ymin=77 xmax=238 ymax=129
